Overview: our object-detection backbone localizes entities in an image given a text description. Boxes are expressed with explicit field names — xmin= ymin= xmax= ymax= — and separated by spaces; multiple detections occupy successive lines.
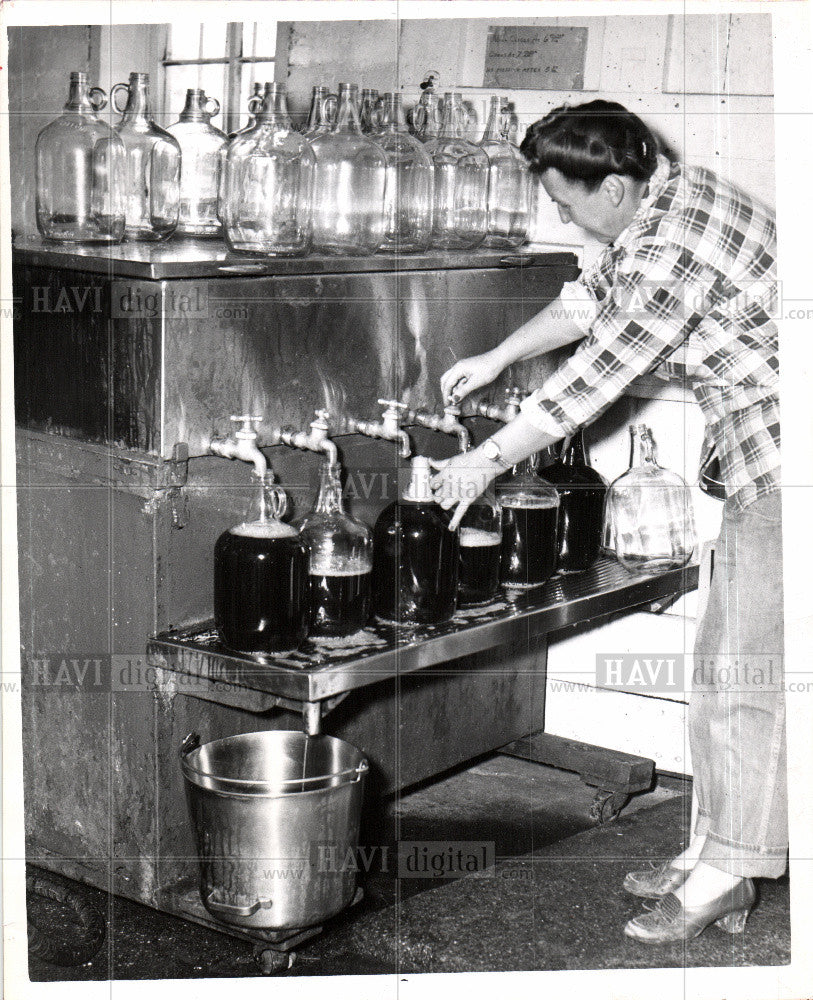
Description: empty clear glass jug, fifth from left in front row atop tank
xmin=311 ymin=83 xmax=387 ymax=256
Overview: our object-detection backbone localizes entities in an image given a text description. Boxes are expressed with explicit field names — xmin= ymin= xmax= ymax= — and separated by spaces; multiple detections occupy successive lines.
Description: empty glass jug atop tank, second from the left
xmin=110 ymin=73 xmax=181 ymax=240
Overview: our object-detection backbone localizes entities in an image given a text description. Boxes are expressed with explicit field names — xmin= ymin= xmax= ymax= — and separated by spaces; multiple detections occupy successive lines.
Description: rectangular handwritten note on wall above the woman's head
xmin=483 ymin=24 xmax=589 ymax=90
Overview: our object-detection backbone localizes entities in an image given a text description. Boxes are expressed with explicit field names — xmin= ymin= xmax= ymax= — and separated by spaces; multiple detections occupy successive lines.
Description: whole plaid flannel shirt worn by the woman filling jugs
xmin=522 ymin=156 xmax=780 ymax=510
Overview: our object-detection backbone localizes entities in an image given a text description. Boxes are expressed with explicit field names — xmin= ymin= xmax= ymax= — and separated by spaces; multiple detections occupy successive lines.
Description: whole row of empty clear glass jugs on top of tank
xmin=36 ymin=73 xmax=531 ymax=256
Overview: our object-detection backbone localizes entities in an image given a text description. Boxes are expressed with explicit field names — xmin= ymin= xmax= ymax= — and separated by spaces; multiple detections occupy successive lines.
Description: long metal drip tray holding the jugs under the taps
xmin=147 ymin=559 xmax=698 ymax=707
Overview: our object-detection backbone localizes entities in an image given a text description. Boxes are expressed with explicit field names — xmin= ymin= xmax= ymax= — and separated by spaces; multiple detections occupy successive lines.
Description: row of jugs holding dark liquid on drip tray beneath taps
xmin=214 ymin=435 xmax=606 ymax=652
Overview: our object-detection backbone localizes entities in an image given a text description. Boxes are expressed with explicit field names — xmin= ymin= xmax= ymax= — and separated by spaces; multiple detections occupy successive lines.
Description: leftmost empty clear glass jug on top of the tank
xmin=35 ymin=73 xmax=125 ymax=243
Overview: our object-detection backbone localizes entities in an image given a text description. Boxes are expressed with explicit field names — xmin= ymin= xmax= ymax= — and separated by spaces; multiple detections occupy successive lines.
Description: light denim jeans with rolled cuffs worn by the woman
xmin=689 ymin=492 xmax=788 ymax=878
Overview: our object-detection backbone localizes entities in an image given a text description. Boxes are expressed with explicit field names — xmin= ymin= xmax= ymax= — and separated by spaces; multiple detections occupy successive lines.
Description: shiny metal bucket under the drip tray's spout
xmin=181 ymin=731 xmax=368 ymax=930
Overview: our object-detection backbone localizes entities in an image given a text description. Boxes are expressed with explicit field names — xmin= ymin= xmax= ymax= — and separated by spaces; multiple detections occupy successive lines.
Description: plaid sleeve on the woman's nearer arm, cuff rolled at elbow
xmin=521 ymin=244 xmax=721 ymax=437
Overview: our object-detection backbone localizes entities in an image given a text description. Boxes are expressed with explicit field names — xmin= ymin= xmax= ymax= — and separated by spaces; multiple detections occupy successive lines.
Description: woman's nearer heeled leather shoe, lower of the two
xmin=624 ymin=878 xmax=757 ymax=944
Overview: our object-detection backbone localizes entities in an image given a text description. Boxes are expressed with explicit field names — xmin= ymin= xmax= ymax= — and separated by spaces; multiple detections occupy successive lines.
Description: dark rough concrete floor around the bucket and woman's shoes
xmin=29 ymin=755 xmax=790 ymax=981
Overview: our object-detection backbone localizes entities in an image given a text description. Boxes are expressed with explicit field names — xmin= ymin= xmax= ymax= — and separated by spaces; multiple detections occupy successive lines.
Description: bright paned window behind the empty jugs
xmin=162 ymin=21 xmax=277 ymax=132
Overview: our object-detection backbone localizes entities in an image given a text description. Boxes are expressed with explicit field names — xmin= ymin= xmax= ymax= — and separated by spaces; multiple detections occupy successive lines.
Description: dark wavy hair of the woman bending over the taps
xmin=519 ymin=100 xmax=658 ymax=191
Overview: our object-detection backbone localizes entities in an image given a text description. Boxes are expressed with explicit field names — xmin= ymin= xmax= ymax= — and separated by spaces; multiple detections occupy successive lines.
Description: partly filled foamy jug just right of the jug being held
xmin=457 ymin=490 xmax=502 ymax=607
